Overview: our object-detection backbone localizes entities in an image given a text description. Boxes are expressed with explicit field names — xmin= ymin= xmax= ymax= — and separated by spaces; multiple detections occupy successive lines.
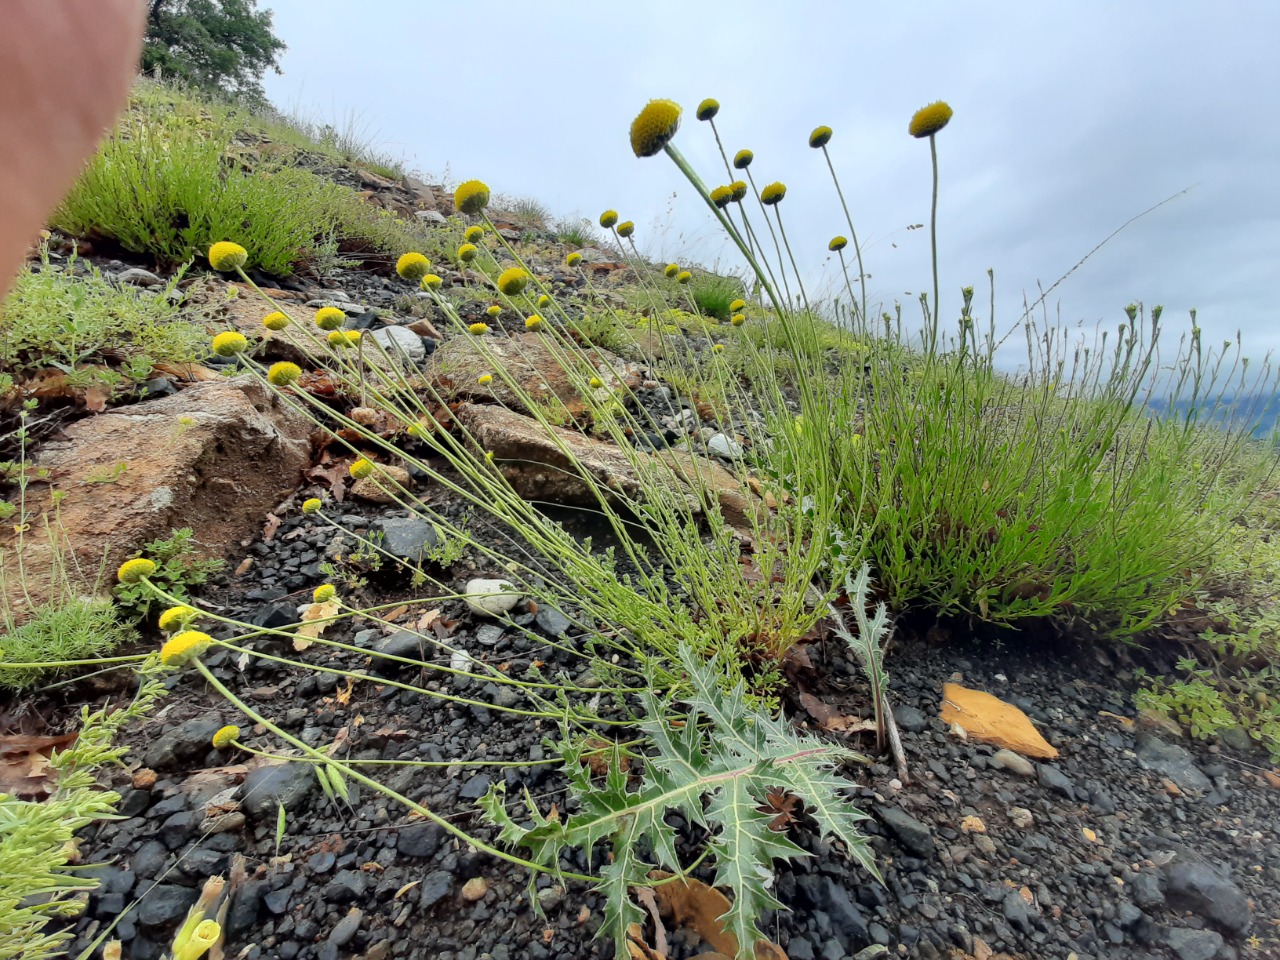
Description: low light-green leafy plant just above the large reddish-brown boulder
xmin=0 ymin=247 xmax=207 ymax=388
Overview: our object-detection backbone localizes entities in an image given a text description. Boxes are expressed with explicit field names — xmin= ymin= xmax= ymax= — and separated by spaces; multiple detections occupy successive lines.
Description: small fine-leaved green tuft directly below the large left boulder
xmin=0 ymin=596 xmax=138 ymax=690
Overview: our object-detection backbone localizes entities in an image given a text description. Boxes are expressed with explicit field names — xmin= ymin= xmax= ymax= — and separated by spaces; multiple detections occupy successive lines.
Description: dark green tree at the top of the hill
xmin=142 ymin=0 xmax=284 ymax=101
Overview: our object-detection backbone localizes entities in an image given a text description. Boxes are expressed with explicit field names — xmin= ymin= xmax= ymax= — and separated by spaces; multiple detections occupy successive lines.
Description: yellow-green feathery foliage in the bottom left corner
xmin=0 ymin=663 xmax=164 ymax=960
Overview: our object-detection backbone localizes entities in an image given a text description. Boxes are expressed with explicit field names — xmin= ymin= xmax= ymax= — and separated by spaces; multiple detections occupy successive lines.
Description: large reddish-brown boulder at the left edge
xmin=0 ymin=376 xmax=311 ymax=614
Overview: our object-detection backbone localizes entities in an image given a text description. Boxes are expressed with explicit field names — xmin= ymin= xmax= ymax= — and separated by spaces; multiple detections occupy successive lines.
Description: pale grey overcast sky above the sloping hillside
xmin=260 ymin=0 xmax=1280 ymax=386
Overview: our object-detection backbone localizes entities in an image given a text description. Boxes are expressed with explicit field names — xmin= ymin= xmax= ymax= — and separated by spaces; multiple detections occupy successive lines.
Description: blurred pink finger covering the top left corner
xmin=0 ymin=0 xmax=146 ymax=297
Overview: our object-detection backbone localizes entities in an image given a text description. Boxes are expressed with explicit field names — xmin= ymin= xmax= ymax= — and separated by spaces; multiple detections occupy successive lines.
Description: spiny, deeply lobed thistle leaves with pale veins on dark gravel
xmin=481 ymin=646 xmax=878 ymax=960
